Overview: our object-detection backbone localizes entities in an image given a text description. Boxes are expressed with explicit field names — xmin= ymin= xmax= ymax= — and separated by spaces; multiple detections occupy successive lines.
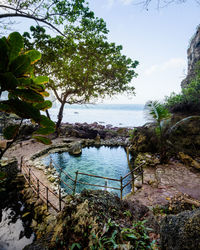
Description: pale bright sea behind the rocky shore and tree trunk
xmin=49 ymin=104 xmax=147 ymax=128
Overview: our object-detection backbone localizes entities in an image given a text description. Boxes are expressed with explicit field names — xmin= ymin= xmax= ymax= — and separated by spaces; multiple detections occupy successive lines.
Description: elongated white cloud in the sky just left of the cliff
xmin=145 ymin=58 xmax=186 ymax=75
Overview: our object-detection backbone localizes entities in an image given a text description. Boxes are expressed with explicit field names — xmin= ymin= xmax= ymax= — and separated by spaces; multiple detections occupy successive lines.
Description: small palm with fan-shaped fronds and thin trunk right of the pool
xmin=145 ymin=101 xmax=171 ymax=162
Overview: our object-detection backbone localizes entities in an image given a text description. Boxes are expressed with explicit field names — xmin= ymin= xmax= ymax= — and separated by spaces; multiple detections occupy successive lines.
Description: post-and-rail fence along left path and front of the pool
xmin=20 ymin=157 xmax=144 ymax=212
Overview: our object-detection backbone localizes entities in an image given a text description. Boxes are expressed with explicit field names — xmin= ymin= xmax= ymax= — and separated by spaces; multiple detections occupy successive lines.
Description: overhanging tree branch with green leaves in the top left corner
xmin=0 ymin=0 xmax=94 ymax=35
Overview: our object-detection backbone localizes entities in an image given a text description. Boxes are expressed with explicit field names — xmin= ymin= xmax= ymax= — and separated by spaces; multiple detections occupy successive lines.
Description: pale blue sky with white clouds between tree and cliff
xmin=4 ymin=0 xmax=200 ymax=104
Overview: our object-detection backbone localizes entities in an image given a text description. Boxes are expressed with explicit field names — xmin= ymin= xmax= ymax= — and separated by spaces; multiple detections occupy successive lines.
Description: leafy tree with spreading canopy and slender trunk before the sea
xmin=24 ymin=25 xmax=138 ymax=134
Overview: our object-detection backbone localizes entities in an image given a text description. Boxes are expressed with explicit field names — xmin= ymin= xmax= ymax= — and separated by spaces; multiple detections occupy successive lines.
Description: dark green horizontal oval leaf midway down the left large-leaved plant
xmin=11 ymin=89 xmax=44 ymax=103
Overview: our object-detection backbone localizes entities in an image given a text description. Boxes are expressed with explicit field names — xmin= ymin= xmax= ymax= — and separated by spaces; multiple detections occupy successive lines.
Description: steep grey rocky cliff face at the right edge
xmin=181 ymin=25 xmax=200 ymax=88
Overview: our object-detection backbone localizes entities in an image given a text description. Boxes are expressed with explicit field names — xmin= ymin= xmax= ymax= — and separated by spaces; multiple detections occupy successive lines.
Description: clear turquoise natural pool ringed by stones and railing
xmin=43 ymin=146 xmax=131 ymax=195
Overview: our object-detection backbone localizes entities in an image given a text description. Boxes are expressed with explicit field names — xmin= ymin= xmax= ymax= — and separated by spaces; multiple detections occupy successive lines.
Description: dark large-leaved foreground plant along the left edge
xmin=0 ymin=32 xmax=54 ymax=158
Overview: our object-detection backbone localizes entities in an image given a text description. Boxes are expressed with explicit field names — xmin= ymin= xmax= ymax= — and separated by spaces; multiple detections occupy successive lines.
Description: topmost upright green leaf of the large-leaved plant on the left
xmin=8 ymin=32 xmax=24 ymax=63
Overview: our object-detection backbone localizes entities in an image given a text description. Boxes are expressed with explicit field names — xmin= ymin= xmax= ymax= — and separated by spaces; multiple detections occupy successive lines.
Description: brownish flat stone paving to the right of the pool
xmin=126 ymin=162 xmax=200 ymax=206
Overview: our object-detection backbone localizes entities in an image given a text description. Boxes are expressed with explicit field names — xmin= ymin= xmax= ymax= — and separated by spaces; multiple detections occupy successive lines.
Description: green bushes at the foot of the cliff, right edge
xmin=165 ymin=62 xmax=200 ymax=114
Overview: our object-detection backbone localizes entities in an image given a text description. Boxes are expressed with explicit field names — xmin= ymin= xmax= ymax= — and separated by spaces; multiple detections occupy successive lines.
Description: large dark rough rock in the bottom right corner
xmin=160 ymin=209 xmax=200 ymax=250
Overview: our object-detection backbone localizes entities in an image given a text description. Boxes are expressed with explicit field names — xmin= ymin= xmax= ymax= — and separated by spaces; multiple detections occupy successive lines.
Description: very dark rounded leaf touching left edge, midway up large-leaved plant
xmin=0 ymin=72 xmax=18 ymax=91
